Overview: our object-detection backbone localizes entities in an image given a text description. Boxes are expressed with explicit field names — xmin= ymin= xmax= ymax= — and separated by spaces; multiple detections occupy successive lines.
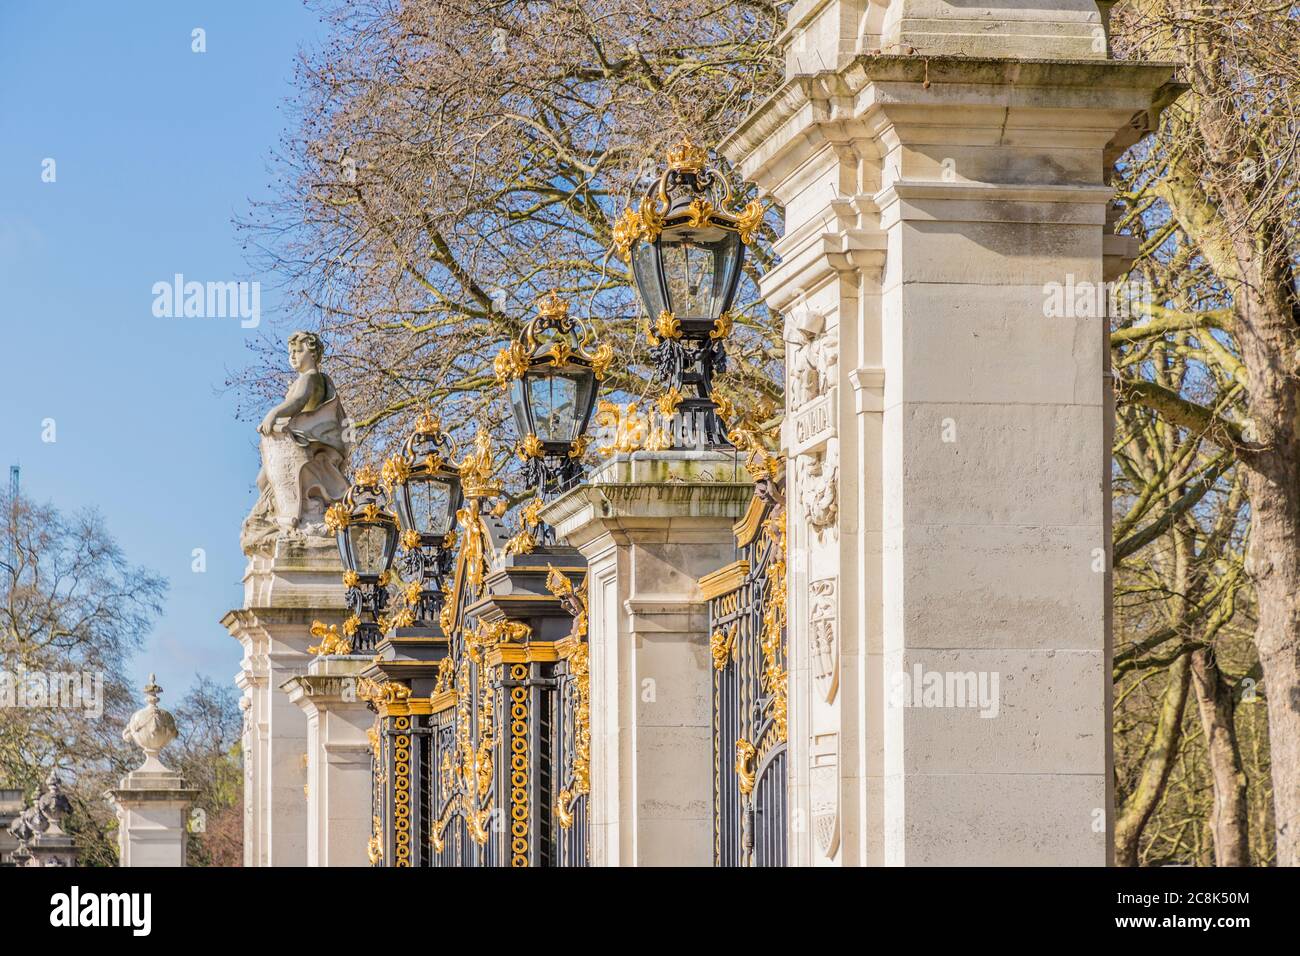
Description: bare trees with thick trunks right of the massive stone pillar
xmin=1112 ymin=0 xmax=1300 ymax=866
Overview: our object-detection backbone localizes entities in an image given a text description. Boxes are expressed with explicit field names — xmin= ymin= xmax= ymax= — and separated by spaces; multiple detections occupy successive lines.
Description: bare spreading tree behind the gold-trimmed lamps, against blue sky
xmin=239 ymin=0 xmax=784 ymax=463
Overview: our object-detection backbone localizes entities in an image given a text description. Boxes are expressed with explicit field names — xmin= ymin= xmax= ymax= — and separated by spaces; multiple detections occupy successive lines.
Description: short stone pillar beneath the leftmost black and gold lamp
xmin=282 ymin=656 xmax=374 ymax=866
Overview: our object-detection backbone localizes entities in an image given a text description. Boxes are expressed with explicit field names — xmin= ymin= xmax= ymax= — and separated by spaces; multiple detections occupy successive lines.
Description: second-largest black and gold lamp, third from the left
xmin=493 ymin=291 xmax=614 ymax=497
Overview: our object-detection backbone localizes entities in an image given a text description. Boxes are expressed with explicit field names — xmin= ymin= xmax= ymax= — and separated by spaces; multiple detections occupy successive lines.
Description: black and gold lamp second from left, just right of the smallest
xmin=384 ymin=412 xmax=463 ymax=627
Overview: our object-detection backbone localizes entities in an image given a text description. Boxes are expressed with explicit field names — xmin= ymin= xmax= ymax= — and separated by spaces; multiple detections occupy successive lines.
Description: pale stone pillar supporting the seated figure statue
xmin=221 ymin=535 xmax=345 ymax=866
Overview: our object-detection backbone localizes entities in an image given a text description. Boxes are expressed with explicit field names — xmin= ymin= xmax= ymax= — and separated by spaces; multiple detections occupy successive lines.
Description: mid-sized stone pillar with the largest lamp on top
xmin=542 ymin=451 xmax=753 ymax=866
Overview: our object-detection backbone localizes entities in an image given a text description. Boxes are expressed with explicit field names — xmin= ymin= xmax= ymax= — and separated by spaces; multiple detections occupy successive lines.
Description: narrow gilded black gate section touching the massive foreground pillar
xmin=699 ymin=455 xmax=789 ymax=866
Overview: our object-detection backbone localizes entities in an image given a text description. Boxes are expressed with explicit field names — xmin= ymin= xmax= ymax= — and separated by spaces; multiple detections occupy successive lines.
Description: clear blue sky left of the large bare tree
xmin=0 ymin=0 xmax=322 ymax=702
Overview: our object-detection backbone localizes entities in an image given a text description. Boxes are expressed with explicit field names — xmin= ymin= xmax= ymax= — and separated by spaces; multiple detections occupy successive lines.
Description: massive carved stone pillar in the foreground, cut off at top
xmin=723 ymin=0 xmax=1171 ymax=865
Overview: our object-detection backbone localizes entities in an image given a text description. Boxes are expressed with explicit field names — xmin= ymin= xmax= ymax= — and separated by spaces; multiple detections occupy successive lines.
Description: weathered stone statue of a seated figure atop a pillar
xmin=239 ymin=332 xmax=348 ymax=554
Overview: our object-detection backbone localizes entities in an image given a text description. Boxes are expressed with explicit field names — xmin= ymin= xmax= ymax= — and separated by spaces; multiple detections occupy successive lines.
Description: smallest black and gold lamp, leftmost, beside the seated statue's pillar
xmin=325 ymin=464 xmax=398 ymax=652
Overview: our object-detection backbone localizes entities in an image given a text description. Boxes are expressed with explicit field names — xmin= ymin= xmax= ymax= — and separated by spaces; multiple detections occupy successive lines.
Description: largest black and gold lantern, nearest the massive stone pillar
xmin=614 ymin=139 xmax=763 ymax=447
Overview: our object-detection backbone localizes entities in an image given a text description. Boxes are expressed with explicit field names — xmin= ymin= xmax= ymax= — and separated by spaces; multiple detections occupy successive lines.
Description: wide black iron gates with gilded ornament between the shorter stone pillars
xmin=361 ymin=431 xmax=590 ymax=866
